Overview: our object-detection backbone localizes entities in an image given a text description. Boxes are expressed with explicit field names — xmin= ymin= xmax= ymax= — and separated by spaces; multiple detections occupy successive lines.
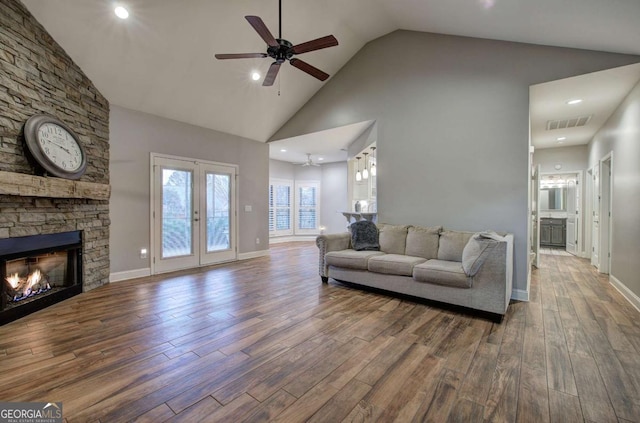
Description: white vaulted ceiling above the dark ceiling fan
xmin=22 ymin=0 xmax=640 ymax=161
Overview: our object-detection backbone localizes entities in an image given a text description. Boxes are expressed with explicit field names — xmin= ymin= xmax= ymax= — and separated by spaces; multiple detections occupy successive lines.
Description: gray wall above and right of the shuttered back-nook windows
xmin=269 ymin=160 xmax=348 ymax=234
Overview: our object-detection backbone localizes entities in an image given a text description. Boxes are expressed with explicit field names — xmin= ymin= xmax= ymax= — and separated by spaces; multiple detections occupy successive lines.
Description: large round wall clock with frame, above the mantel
xmin=24 ymin=115 xmax=87 ymax=179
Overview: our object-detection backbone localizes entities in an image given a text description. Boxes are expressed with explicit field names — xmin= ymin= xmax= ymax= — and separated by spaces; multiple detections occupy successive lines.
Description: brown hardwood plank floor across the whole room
xmin=0 ymin=243 xmax=640 ymax=423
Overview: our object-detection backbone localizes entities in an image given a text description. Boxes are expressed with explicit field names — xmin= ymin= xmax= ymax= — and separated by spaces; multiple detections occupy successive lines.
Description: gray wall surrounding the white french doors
xmin=109 ymin=105 xmax=269 ymax=273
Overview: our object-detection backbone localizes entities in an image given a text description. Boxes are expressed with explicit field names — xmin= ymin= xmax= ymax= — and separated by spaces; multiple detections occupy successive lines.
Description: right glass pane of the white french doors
xmin=206 ymin=173 xmax=231 ymax=252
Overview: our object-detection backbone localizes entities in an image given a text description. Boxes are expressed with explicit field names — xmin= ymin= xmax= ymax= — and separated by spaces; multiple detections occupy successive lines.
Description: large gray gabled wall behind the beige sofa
xmin=273 ymin=31 xmax=640 ymax=296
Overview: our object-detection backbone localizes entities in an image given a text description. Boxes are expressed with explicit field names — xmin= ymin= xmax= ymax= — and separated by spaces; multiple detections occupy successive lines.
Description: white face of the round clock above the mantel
xmin=38 ymin=122 xmax=82 ymax=172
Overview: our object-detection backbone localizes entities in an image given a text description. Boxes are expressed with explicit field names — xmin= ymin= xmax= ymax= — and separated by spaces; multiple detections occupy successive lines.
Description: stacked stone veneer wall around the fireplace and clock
xmin=0 ymin=0 xmax=110 ymax=291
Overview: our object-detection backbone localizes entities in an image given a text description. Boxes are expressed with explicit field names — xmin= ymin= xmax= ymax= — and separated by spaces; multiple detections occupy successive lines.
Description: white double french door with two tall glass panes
xmin=151 ymin=156 xmax=237 ymax=273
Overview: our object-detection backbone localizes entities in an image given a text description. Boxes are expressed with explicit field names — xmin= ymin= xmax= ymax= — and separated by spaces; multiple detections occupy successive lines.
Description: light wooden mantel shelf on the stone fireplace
xmin=0 ymin=171 xmax=111 ymax=200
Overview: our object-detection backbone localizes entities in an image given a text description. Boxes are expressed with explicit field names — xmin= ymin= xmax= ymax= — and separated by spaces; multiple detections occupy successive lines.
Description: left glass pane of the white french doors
xmin=162 ymin=168 xmax=193 ymax=258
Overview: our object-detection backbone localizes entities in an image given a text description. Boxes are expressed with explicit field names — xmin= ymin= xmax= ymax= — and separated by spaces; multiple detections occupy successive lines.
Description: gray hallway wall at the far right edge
xmin=588 ymin=79 xmax=640 ymax=296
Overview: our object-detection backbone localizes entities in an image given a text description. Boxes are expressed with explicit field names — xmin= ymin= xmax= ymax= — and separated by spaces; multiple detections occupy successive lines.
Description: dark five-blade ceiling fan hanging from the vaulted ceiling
xmin=215 ymin=0 xmax=338 ymax=87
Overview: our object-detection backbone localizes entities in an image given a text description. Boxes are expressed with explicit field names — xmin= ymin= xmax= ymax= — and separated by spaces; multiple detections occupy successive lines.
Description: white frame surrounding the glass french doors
xmin=149 ymin=152 xmax=240 ymax=275
